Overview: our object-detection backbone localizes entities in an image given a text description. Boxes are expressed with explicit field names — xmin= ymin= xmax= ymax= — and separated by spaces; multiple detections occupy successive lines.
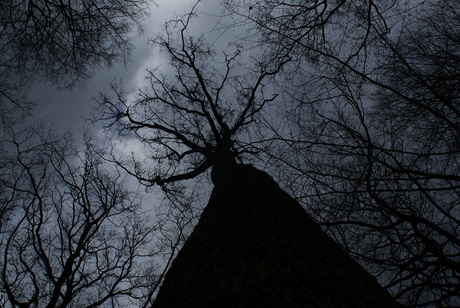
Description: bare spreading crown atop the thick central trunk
xmin=100 ymin=7 xmax=282 ymax=186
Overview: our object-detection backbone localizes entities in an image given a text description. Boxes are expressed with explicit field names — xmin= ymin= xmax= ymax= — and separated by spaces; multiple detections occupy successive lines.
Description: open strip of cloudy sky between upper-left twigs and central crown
xmin=29 ymin=0 xmax=218 ymax=130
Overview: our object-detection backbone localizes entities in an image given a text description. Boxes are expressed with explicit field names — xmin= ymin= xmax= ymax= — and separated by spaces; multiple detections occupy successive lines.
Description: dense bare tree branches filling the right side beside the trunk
xmin=227 ymin=1 xmax=460 ymax=307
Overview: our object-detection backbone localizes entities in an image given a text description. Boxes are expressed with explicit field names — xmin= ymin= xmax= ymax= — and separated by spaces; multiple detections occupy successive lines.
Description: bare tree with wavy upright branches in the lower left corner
xmin=0 ymin=125 xmax=163 ymax=307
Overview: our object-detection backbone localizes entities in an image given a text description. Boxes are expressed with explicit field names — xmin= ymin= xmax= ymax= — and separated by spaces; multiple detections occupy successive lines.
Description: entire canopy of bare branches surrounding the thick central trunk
xmin=0 ymin=0 xmax=460 ymax=307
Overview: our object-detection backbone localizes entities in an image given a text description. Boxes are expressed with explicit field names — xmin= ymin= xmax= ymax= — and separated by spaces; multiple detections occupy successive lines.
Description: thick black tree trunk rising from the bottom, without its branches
xmin=153 ymin=164 xmax=399 ymax=308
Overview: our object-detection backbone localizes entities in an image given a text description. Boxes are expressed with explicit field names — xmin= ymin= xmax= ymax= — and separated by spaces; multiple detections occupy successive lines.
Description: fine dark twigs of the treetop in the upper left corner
xmin=0 ymin=0 xmax=153 ymax=125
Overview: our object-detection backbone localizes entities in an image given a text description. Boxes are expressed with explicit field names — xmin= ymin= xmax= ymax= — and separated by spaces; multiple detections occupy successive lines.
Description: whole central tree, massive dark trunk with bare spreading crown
xmin=100 ymin=10 xmax=398 ymax=307
